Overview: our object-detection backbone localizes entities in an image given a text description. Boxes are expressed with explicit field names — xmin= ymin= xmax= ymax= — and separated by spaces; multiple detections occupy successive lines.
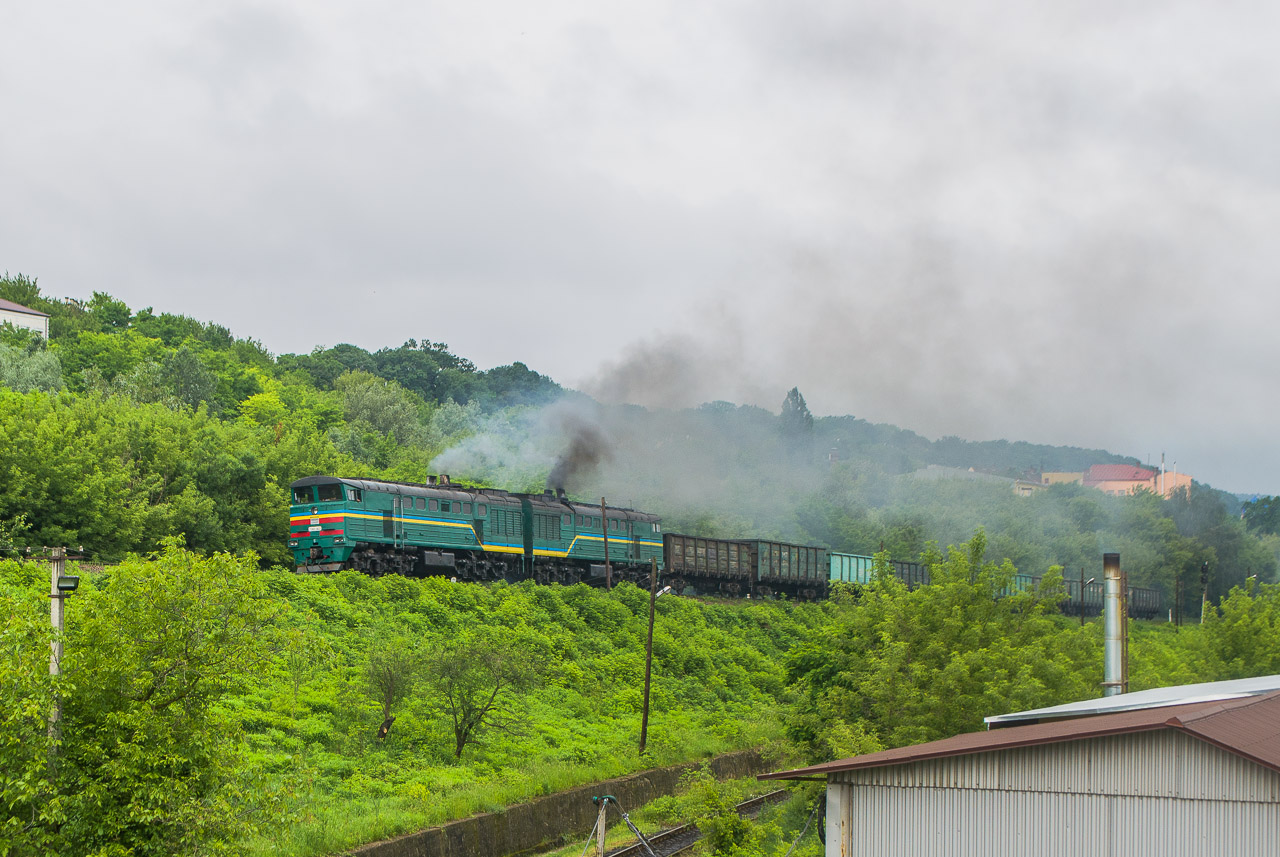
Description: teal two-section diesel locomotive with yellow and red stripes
xmin=289 ymin=476 xmax=662 ymax=583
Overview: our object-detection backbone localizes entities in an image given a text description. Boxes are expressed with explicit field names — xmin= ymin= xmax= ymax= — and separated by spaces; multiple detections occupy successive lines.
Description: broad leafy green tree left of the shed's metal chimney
xmin=788 ymin=532 xmax=1101 ymax=756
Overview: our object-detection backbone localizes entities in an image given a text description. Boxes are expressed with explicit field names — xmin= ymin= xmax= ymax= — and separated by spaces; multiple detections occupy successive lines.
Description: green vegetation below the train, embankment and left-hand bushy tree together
xmin=0 ymin=545 xmax=824 ymax=857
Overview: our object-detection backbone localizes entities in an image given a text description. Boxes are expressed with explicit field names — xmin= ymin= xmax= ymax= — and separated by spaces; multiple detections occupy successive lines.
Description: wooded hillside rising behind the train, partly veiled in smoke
xmin=0 ymin=269 xmax=1280 ymax=603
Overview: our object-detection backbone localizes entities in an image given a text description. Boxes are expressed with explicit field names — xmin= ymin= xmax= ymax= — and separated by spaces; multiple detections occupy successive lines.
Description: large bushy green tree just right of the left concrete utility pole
xmin=58 ymin=542 xmax=276 ymax=857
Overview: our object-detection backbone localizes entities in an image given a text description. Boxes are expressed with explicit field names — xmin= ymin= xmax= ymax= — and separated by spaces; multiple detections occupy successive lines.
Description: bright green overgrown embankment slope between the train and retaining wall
xmin=233 ymin=570 xmax=827 ymax=854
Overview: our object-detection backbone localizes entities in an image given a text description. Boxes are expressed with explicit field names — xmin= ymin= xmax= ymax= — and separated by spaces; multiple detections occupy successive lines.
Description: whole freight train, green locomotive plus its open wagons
xmin=289 ymin=476 xmax=1162 ymax=618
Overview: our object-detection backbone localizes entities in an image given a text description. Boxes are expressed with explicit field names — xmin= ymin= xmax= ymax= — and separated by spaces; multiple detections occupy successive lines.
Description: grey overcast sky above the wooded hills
xmin=0 ymin=0 xmax=1280 ymax=492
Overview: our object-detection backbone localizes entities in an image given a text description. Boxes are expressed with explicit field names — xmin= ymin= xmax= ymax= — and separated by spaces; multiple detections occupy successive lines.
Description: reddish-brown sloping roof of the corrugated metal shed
xmin=760 ymin=692 xmax=1280 ymax=779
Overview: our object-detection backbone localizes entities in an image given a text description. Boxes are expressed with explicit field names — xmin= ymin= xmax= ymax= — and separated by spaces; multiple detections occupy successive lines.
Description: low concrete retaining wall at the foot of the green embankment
xmin=347 ymin=750 xmax=767 ymax=857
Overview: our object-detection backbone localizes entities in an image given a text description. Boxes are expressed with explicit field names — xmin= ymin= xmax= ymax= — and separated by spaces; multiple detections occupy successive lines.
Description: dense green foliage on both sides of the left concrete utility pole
xmin=0 ymin=545 xmax=278 ymax=857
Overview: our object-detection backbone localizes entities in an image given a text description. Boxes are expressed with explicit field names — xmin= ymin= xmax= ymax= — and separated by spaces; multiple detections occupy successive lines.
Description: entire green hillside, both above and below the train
xmin=0 ymin=276 xmax=1280 ymax=857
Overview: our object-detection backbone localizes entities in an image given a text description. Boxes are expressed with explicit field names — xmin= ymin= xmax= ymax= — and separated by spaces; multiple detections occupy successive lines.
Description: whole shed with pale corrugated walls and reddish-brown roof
xmin=762 ymin=677 xmax=1280 ymax=857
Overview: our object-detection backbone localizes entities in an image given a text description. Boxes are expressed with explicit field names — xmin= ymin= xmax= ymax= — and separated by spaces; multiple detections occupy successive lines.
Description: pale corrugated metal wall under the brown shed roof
xmin=827 ymin=730 xmax=1280 ymax=857
